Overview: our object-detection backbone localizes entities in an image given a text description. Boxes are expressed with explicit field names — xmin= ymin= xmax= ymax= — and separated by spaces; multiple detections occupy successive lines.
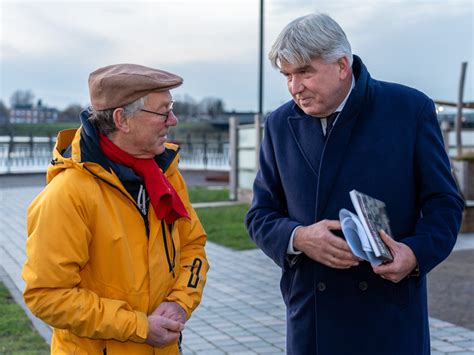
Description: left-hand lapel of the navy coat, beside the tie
xmin=288 ymin=115 xmax=324 ymax=176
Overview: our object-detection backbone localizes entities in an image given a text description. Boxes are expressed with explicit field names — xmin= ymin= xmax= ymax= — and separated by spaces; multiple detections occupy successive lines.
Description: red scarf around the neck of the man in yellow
xmin=99 ymin=133 xmax=189 ymax=224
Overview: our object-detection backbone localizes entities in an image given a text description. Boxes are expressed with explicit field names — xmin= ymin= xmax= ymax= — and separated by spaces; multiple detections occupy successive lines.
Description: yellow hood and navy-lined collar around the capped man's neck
xmin=47 ymin=109 xmax=179 ymax=185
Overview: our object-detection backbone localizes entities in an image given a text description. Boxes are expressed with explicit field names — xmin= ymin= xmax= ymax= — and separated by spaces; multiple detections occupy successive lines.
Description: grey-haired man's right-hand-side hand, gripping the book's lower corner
xmin=373 ymin=230 xmax=417 ymax=282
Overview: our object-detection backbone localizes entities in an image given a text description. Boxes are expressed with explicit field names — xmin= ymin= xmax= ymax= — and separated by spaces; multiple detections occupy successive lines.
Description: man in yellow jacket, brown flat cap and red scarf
xmin=23 ymin=64 xmax=209 ymax=355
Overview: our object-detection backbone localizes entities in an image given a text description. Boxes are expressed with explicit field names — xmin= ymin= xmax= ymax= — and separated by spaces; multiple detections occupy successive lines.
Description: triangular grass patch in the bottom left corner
xmin=0 ymin=283 xmax=49 ymax=355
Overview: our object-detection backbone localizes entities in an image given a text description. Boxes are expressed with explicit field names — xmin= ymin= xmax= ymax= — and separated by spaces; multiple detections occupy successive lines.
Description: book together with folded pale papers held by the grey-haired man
xmin=339 ymin=190 xmax=393 ymax=265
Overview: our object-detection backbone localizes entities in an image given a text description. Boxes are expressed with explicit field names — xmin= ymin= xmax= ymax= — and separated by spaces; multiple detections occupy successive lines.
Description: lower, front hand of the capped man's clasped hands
xmin=146 ymin=314 xmax=184 ymax=347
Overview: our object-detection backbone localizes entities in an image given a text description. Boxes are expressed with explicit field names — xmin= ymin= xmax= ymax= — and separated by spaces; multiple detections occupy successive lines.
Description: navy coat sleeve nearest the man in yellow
xmin=245 ymin=117 xmax=300 ymax=268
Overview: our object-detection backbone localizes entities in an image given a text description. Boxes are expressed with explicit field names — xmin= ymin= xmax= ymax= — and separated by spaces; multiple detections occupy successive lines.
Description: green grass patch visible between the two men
xmin=196 ymin=204 xmax=256 ymax=250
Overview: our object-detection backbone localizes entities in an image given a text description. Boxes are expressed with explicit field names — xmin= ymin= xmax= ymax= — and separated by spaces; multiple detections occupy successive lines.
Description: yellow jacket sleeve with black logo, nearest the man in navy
xmin=166 ymin=171 xmax=209 ymax=319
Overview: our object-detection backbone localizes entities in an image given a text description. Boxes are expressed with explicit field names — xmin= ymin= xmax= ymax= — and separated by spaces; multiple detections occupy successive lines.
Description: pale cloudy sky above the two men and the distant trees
xmin=0 ymin=0 xmax=474 ymax=111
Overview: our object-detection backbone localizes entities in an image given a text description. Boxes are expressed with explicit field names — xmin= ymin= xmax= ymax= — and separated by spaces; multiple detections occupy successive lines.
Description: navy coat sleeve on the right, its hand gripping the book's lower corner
xmin=401 ymin=100 xmax=464 ymax=276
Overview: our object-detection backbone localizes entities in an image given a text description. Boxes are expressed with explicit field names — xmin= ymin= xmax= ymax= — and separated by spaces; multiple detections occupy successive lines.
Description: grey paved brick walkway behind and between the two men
xmin=0 ymin=187 xmax=474 ymax=355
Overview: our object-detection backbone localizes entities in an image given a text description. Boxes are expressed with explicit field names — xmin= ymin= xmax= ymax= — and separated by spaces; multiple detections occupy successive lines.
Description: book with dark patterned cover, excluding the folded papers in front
xmin=349 ymin=190 xmax=393 ymax=261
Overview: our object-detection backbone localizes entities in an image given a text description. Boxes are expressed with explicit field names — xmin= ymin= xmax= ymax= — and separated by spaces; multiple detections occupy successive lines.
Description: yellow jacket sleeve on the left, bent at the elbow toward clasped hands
xmin=22 ymin=177 xmax=148 ymax=342
